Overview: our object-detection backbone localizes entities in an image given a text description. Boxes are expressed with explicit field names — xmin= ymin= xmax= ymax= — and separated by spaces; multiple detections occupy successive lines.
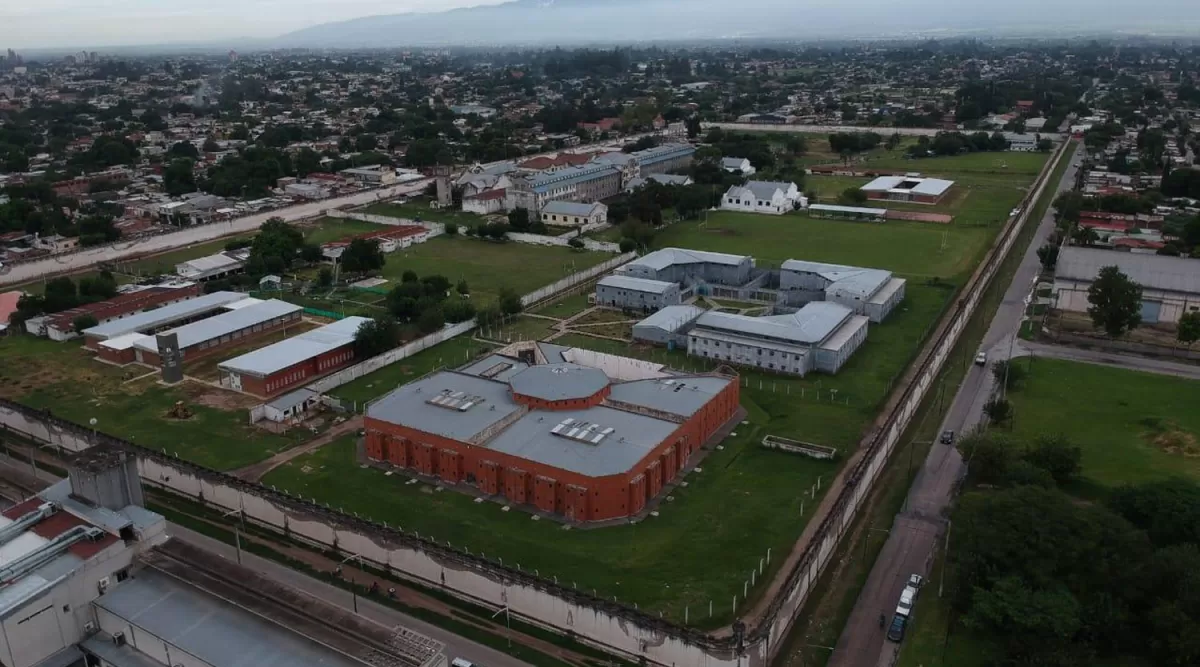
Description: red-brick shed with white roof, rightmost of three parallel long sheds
xmin=217 ymin=317 xmax=371 ymax=398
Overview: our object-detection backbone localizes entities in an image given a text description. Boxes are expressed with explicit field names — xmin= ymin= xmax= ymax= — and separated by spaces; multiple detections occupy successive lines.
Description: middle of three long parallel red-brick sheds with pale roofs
xmin=131 ymin=299 xmax=304 ymax=367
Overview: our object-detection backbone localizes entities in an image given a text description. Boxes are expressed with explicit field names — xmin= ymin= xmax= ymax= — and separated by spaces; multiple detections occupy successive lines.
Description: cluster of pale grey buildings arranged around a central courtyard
xmin=595 ymin=248 xmax=906 ymax=375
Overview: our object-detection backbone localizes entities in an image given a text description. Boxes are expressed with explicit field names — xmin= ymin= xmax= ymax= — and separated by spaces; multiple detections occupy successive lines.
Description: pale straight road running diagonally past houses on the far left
xmin=0 ymin=179 xmax=430 ymax=286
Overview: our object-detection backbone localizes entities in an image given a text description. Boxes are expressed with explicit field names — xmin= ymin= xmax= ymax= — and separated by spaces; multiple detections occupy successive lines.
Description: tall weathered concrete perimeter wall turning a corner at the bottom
xmin=0 ymin=144 xmax=1069 ymax=667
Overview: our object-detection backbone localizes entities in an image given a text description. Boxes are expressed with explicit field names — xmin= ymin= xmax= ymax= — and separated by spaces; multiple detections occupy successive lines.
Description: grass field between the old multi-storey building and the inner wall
xmin=383 ymin=236 xmax=612 ymax=302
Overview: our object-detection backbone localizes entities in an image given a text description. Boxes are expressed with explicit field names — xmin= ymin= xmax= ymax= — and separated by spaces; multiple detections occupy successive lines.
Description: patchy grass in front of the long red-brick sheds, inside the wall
xmin=0 ymin=336 xmax=312 ymax=470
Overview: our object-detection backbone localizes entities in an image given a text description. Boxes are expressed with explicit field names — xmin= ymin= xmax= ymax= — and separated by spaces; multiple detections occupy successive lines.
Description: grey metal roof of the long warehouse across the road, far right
xmin=1055 ymin=246 xmax=1200 ymax=294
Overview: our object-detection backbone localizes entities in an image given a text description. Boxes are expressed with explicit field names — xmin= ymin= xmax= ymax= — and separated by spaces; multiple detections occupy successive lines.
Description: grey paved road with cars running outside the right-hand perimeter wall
xmin=828 ymin=142 xmax=1079 ymax=667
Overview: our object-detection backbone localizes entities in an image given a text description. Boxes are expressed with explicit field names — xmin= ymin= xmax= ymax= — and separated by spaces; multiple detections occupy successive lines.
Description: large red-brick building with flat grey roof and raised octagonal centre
xmin=365 ymin=348 xmax=739 ymax=522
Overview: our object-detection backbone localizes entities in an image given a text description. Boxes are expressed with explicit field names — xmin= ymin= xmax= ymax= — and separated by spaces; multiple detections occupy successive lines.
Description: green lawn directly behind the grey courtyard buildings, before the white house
xmin=654 ymin=211 xmax=1000 ymax=278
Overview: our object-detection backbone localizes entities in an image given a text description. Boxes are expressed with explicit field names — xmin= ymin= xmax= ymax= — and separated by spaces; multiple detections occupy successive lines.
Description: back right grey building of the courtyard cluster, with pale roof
xmin=779 ymin=259 xmax=907 ymax=323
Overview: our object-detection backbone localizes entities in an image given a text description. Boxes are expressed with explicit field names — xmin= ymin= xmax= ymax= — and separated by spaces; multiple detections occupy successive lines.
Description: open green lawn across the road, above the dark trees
xmin=1009 ymin=359 xmax=1200 ymax=487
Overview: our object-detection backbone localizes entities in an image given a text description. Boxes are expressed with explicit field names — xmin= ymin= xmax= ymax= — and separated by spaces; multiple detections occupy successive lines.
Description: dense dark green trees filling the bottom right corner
xmin=948 ymin=433 xmax=1200 ymax=667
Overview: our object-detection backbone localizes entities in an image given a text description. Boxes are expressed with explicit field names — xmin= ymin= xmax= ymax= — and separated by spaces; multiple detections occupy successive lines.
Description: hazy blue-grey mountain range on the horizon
xmin=270 ymin=0 xmax=1198 ymax=48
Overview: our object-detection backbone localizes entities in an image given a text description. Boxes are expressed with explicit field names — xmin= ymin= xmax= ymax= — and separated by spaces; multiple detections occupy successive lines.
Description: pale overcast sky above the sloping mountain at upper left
xmin=0 ymin=0 xmax=503 ymax=49
